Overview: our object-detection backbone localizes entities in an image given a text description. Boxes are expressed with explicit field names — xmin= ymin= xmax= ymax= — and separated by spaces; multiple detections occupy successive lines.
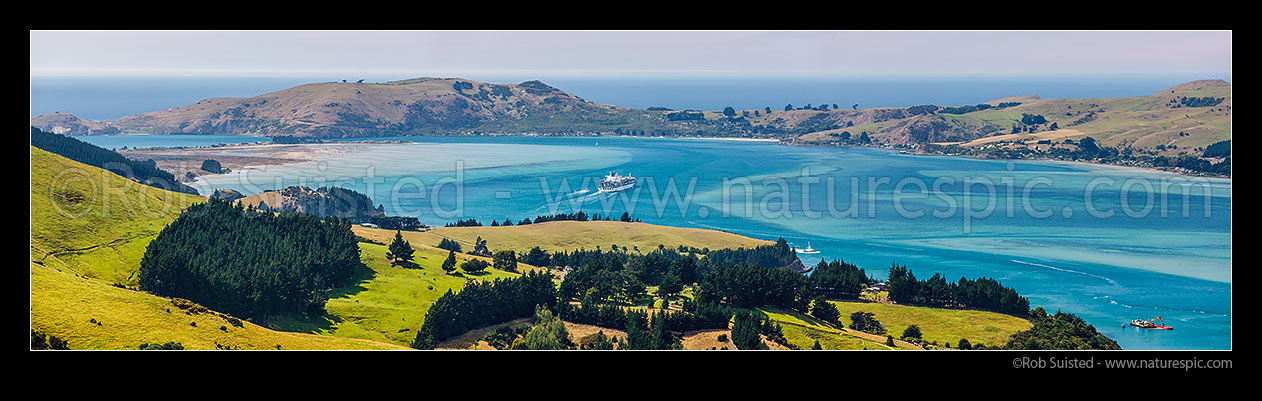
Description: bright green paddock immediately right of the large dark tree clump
xmin=276 ymin=242 xmax=526 ymax=346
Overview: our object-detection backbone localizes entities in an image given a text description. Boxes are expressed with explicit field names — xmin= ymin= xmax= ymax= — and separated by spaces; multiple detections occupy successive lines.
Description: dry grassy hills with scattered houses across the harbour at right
xmin=786 ymin=79 xmax=1232 ymax=156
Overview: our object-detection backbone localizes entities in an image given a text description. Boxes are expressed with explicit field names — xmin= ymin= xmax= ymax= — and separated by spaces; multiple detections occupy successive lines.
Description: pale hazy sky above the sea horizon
xmin=30 ymin=32 xmax=1232 ymax=79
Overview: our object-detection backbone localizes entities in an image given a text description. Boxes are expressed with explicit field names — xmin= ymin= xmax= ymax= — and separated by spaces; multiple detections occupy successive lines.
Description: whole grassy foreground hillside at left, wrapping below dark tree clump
xmin=30 ymin=148 xmax=401 ymax=349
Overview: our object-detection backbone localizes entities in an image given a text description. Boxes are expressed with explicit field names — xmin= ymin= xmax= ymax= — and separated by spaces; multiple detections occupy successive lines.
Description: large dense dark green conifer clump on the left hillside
xmin=138 ymin=198 xmax=363 ymax=318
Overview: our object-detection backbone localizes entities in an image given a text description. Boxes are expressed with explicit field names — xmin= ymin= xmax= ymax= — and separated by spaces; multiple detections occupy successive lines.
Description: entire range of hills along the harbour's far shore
xmin=30 ymin=78 xmax=1232 ymax=156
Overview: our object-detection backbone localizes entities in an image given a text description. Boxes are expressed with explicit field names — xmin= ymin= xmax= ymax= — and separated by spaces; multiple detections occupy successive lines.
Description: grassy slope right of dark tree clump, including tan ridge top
xmin=345 ymin=221 xmax=771 ymax=348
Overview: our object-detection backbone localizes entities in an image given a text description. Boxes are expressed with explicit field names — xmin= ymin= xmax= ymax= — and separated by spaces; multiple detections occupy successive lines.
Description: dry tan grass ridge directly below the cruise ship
xmin=424 ymin=221 xmax=772 ymax=253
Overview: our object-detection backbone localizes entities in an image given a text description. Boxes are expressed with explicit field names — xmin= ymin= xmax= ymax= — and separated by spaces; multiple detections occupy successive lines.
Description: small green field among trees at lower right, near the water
xmin=832 ymin=301 xmax=1031 ymax=347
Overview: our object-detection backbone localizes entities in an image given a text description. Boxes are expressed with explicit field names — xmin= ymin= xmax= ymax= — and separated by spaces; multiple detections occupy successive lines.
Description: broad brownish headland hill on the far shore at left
xmin=30 ymin=78 xmax=654 ymax=137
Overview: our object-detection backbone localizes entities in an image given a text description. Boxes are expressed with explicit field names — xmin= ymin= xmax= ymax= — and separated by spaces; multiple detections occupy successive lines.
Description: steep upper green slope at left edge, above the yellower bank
xmin=30 ymin=146 xmax=206 ymax=286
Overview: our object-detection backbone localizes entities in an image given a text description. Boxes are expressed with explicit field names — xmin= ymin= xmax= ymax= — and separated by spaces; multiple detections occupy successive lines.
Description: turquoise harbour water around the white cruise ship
xmin=93 ymin=137 xmax=1232 ymax=349
